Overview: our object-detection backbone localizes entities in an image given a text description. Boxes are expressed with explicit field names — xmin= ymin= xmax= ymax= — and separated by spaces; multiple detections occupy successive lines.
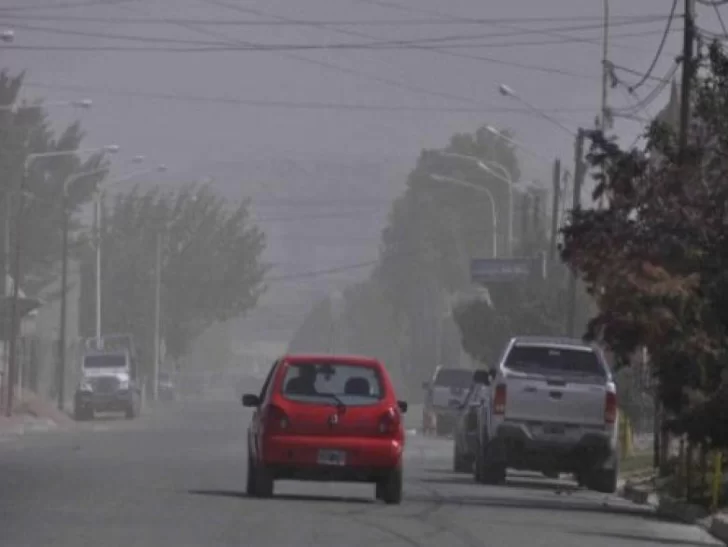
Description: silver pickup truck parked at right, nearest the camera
xmin=474 ymin=336 xmax=619 ymax=493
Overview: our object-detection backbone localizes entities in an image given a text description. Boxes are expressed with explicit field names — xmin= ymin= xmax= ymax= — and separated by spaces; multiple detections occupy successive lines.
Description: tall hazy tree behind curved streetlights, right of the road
xmin=288 ymin=126 xmax=520 ymax=386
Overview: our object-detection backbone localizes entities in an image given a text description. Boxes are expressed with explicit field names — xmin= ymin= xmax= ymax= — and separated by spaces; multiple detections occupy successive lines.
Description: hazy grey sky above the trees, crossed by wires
xmin=0 ymin=0 xmax=716 ymax=340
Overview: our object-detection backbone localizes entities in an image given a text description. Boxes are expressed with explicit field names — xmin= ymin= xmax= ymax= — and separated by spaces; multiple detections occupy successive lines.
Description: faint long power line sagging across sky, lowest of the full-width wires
xmin=23 ymin=81 xmax=591 ymax=113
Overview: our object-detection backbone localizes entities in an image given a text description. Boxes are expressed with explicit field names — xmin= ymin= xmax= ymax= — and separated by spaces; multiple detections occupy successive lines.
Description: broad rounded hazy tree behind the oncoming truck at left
xmin=85 ymin=185 xmax=267 ymax=368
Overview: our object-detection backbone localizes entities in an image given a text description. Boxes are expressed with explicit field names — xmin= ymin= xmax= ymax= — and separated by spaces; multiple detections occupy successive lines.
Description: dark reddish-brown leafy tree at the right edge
xmin=562 ymin=44 xmax=728 ymax=446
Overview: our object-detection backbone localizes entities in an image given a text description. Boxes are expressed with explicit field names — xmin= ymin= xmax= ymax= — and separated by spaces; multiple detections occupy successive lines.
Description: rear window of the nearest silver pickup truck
xmin=505 ymin=346 xmax=607 ymax=378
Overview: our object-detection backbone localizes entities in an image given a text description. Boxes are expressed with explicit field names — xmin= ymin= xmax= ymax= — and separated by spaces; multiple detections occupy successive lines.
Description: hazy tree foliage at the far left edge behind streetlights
xmin=0 ymin=71 xmax=106 ymax=294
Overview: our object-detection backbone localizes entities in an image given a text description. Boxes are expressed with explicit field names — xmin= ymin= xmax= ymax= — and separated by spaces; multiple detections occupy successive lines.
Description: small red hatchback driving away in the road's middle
xmin=243 ymin=355 xmax=407 ymax=504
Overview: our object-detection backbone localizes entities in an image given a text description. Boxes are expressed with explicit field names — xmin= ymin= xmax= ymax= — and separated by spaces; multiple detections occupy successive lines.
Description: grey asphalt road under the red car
xmin=0 ymin=403 xmax=719 ymax=547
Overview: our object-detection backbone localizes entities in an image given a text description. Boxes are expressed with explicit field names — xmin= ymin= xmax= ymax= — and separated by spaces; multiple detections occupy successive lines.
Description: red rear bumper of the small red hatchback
xmin=261 ymin=435 xmax=404 ymax=469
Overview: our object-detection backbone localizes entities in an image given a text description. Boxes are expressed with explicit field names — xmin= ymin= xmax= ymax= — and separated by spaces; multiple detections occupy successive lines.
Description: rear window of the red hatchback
xmin=282 ymin=363 xmax=385 ymax=406
